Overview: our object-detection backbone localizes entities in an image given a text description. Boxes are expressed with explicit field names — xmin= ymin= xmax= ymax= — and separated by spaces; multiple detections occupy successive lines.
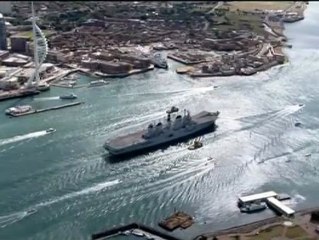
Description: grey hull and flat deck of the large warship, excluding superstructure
xmin=104 ymin=112 xmax=217 ymax=157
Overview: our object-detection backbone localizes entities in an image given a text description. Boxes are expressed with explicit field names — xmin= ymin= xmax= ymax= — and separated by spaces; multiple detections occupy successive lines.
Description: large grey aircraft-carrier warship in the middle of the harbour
xmin=104 ymin=107 xmax=219 ymax=156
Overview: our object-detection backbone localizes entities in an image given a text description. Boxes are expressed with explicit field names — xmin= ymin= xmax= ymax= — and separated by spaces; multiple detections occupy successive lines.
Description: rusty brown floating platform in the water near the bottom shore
xmin=158 ymin=212 xmax=194 ymax=231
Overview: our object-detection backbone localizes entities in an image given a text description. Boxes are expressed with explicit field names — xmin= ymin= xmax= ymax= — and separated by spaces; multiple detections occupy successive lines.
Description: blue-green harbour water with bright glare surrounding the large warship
xmin=0 ymin=2 xmax=319 ymax=240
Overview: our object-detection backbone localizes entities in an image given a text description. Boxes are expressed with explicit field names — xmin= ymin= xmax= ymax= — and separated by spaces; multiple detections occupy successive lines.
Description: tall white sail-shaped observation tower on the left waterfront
xmin=26 ymin=2 xmax=48 ymax=88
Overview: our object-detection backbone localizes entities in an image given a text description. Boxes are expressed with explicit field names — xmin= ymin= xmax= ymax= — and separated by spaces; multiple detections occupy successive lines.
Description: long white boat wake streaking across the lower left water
xmin=0 ymin=179 xmax=121 ymax=228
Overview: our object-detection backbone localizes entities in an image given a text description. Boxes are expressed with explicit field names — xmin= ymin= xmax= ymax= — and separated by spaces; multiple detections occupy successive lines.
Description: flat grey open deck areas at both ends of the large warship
xmin=106 ymin=111 xmax=216 ymax=149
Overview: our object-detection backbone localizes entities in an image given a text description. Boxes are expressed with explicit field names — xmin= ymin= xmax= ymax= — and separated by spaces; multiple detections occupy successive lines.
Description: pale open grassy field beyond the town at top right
xmin=229 ymin=1 xmax=293 ymax=11
